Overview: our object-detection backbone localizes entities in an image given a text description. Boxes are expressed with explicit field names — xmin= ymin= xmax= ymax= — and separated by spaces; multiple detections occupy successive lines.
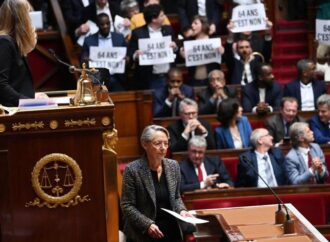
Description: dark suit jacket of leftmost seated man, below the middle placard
xmin=152 ymin=84 xmax=194 ymax=117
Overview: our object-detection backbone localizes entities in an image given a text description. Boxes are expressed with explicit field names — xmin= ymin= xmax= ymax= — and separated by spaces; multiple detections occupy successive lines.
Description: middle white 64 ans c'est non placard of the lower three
xmin=138 ymin=36 xmax=175 ymax=66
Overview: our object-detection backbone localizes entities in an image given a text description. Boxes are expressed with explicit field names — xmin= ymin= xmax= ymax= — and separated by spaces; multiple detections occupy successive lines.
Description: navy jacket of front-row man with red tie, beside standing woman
xmin=179 ymin=156 xmax=233 ymax=193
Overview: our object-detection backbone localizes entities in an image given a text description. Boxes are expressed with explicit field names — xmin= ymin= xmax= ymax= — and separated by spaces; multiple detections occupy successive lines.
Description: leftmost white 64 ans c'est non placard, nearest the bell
xmin=89 ymin=46 xmax=127 ymax=75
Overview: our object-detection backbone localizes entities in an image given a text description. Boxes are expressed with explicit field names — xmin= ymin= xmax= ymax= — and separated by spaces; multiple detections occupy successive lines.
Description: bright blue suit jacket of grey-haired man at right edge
xmin=309 ymin=114 xmax=330 ymax=144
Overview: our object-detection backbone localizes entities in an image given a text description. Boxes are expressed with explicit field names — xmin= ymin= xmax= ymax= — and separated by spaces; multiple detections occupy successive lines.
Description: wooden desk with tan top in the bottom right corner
xmin=194 ymin=204 xmax=328 ymax=242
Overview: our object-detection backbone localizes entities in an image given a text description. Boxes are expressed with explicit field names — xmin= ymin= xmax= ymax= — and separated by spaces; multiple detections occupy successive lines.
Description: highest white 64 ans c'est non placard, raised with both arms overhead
xmin=231 ymin=3 xmax=267 ymax=33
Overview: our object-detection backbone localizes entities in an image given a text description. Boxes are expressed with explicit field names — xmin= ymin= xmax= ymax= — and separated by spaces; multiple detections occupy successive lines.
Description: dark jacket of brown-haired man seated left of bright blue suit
xmin=265 ymin=113 xmax=305 ymax=143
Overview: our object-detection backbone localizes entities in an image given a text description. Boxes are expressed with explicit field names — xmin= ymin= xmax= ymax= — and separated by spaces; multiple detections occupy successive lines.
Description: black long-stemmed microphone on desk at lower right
xmin=242 ymin=155 xmax=295 ymax=234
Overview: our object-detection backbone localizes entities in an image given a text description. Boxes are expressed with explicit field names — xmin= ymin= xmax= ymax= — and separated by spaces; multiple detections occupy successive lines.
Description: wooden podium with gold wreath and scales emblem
xmin=0 ymin=103 xmax=119 ymax=242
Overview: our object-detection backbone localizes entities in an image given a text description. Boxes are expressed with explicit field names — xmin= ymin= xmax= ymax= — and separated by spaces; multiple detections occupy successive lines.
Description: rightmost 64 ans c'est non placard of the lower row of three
xmin=183 ymin=38 xmax=221 ymax=66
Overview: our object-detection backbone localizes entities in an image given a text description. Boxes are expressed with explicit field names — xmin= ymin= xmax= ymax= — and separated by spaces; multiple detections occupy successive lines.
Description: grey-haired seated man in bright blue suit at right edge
xmin=310 ymin=94 xmax=330 ymax=144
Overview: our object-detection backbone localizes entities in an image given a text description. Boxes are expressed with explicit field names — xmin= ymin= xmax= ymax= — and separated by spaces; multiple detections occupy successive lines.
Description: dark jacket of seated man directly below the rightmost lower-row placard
xmin=196 ymin=86 xmax=236 ymax=114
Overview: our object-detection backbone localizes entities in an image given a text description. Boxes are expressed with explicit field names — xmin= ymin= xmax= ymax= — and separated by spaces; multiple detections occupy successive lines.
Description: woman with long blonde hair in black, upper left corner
xmin=0 ymin=0 xmax=37 ymax=106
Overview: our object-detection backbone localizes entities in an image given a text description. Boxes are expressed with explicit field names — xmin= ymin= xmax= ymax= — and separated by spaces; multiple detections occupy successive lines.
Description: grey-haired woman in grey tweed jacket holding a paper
xmin=121 ymin=125 xmax=191 ymax=242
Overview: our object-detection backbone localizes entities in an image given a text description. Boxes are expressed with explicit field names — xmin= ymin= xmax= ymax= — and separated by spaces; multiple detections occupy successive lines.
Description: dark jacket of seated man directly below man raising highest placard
xmin=242 ymin=81 xmax=282 ymax=112
